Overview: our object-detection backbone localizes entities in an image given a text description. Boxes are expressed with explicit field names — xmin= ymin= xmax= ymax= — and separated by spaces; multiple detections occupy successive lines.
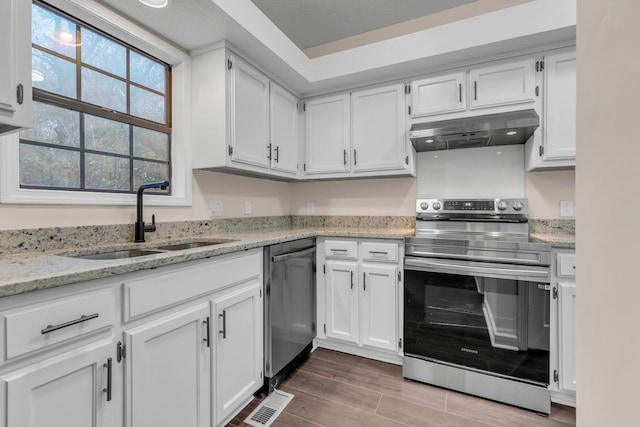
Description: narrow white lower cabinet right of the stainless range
xmin=549 ymin=249 xmax=576 ymax=406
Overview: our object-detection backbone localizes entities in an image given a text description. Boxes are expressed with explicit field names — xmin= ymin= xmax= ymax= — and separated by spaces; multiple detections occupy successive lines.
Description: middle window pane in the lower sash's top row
xmin=84 ymin=114 xmax=129 ymax=155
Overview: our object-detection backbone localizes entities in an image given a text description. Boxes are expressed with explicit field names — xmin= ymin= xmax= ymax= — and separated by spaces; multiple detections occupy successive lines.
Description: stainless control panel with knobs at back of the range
xmin=416 ymin=199 xmax=529 ymax=215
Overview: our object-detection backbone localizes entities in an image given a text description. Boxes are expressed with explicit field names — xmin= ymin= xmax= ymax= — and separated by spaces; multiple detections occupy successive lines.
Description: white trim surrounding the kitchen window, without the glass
xmin=0 ymin=0 xmax=192 ymax=206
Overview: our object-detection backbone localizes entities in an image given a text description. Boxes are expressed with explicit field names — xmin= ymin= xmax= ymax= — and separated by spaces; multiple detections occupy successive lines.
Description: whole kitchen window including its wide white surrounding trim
xmin=0 ymin=0 xmax=191 ymax=206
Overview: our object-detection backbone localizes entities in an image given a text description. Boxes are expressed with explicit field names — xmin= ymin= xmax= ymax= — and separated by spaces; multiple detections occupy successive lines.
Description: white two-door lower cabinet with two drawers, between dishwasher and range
xmin=317 ymin=238 xmax=403 ymax=363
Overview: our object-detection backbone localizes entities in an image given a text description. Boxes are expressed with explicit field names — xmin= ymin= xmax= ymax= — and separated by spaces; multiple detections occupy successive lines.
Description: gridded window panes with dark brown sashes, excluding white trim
xmin=20 ymin=2 xmax=171 ymax=193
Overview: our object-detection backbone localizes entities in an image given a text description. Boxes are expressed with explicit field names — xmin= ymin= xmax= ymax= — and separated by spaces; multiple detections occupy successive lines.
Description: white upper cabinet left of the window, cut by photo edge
xmin=0 ymin=0 xmax=32 ymax=134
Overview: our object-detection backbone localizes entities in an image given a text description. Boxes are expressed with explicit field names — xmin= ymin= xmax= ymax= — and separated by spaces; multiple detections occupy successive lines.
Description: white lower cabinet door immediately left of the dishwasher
xmin=213 ymin=281 xmax=263 ymax=426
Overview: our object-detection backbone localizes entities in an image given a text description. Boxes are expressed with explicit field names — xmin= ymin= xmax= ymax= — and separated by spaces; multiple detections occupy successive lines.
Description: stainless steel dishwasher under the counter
xmin=264 ymin=238 xmax=316 ymax=393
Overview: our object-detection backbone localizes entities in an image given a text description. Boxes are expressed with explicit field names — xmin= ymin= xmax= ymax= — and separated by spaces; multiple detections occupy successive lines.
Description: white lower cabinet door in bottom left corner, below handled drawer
xmin=0 ymin=338 xmax=114 ymax=427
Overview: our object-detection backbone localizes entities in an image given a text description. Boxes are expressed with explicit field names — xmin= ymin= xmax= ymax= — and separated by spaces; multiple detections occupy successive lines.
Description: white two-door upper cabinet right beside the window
xmin=191 ymin=48 xmax=300 ymax=180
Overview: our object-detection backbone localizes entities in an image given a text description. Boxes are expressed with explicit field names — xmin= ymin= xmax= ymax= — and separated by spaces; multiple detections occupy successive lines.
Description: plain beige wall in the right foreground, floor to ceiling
xmin=576 ymin=0 xmax=640 ymax=427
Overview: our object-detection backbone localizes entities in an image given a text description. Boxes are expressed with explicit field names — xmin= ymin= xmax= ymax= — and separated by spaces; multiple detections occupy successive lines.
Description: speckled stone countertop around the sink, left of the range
xmin=0 ymin=217 xmax=414 ymax=297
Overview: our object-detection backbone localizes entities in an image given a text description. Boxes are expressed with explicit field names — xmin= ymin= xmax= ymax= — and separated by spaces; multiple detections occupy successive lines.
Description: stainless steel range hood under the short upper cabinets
xmin=409 ymin=109 xmax=540 ymax=152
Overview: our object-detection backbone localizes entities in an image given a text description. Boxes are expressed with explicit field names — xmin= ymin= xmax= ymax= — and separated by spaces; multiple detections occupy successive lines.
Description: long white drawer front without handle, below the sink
xmin=123 ymin=249 xmax=262 ymax=321
